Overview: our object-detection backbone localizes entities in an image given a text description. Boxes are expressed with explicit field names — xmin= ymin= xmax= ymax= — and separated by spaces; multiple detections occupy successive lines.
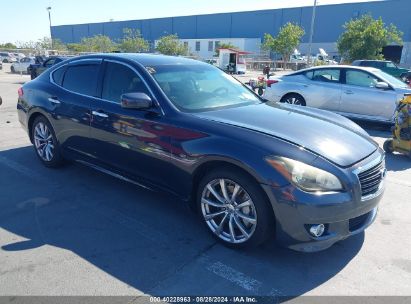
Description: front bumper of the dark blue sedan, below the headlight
xmin=262 ymin=152 xmax=385 ymax=252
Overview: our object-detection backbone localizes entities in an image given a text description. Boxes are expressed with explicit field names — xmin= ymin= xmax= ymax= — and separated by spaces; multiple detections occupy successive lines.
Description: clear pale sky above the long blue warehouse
xmin=0 ymin=0 xmax=380 ymax=43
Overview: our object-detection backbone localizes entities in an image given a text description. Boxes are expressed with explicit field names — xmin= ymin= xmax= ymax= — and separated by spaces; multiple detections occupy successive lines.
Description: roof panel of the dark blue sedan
xmin=69 ymin=53 xmax=208 ymax=66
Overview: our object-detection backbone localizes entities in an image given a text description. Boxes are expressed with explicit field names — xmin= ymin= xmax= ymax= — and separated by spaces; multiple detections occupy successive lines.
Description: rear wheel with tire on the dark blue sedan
xmin=31 ymin=116 xmax=64 ymax=168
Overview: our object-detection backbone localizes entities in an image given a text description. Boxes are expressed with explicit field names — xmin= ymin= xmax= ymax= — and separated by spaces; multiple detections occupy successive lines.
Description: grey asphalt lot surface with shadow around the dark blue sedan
xmin=0 ymin=64 xmax=411 ymax=297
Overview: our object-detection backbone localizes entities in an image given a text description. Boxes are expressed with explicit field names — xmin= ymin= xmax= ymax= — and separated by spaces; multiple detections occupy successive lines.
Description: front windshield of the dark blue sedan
xmin=147 ymin=64 xmax=261 ymax=112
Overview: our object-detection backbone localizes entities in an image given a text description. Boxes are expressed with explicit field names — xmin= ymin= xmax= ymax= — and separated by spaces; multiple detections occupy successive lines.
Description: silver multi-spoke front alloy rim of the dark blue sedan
xmin=201 ymin=179 xmax=257 ymax=244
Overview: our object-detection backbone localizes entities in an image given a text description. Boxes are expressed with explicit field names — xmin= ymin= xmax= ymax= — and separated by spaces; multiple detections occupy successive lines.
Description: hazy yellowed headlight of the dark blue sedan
xmin=266 ymin=157 xmax=343 ymax=192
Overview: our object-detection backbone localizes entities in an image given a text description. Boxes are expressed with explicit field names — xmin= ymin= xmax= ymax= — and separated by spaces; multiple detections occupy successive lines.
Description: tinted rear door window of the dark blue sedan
xmin=63 ymin=64 xmax=100 ymax=96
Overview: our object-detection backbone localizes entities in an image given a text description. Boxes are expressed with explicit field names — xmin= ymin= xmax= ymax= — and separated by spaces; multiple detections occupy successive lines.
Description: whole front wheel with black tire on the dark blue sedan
xmin=197 ymin=167 xmax=274 ymax=249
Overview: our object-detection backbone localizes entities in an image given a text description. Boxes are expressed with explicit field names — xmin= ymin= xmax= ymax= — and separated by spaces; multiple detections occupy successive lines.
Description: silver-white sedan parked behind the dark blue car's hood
xmin=263 ymin=65 xmax=411 ymax=123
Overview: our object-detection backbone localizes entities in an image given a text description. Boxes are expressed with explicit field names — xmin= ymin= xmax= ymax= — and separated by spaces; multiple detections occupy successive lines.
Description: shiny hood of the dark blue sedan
xmin=194 ymin=103 xmax=378 ymax=167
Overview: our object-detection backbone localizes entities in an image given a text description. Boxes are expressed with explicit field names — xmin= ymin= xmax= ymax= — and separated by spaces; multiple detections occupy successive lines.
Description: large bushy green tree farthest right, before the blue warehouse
xmin=337 ymin=15 xmax=403 ymax=62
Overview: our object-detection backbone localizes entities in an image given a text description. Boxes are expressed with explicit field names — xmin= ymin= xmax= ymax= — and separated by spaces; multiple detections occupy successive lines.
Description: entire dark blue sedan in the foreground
xmin=17 ymin=54 xmax=386 ymax=251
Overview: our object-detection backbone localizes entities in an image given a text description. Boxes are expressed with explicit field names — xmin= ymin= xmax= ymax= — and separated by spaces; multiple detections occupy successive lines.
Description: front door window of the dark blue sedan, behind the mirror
xmin=102 ymin=62 xmax=149 ymax=103
